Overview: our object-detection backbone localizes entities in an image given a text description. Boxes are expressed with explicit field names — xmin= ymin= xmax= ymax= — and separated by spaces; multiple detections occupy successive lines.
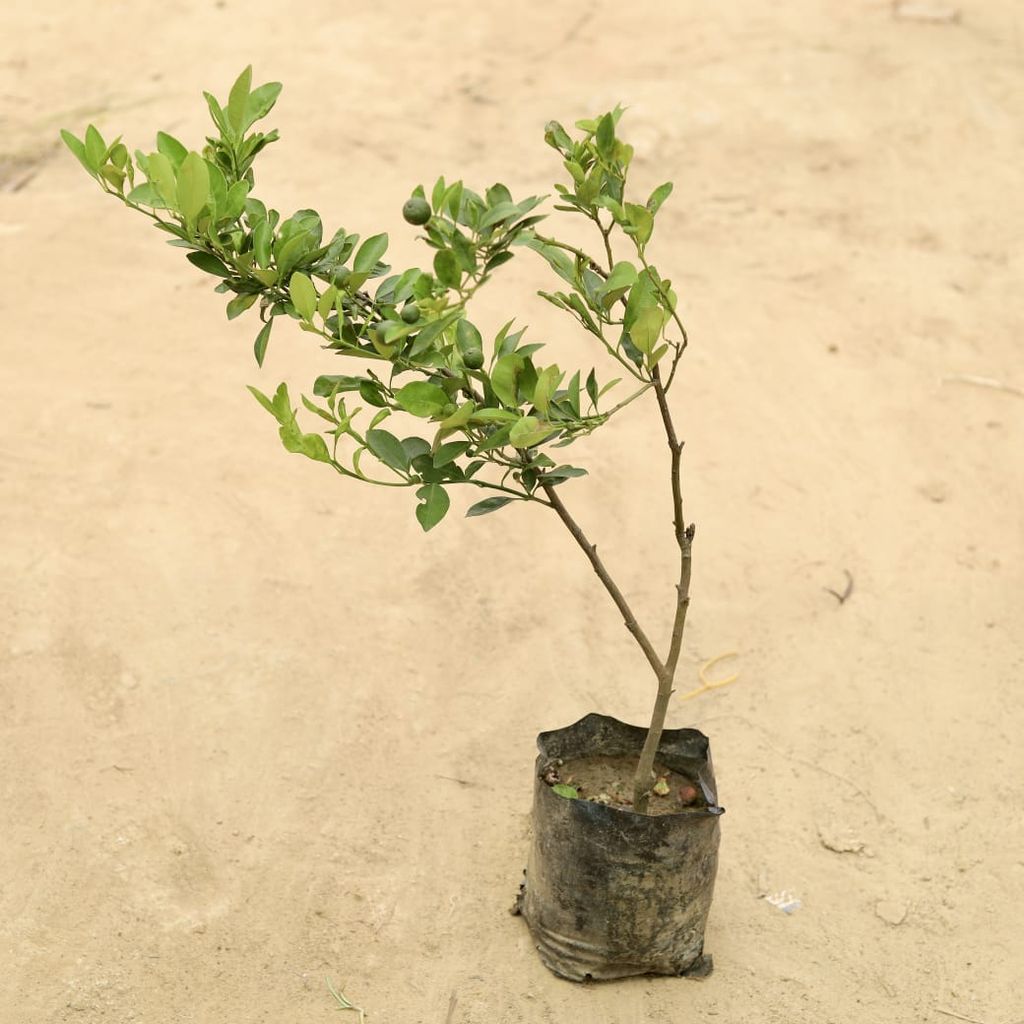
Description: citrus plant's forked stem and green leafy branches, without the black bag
xmin=61 ymin=68 xmax=693 ymax=812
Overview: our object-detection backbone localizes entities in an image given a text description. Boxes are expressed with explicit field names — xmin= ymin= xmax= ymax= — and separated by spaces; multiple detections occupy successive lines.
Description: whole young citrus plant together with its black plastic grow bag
xmin=61 ymin=69 xmax=722 ymax=980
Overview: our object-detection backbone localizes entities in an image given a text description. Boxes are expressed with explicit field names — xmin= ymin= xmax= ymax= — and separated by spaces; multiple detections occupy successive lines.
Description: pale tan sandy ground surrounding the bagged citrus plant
xmin=0 ymin=0 xmax=1024 ymax=1024
